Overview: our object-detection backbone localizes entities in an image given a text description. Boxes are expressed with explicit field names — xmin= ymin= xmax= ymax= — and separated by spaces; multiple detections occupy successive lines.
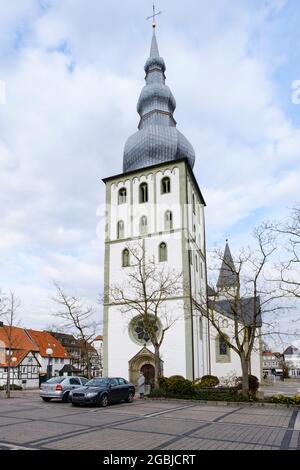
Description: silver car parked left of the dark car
xmin=40 ymin=376 xmax=88 ymax=402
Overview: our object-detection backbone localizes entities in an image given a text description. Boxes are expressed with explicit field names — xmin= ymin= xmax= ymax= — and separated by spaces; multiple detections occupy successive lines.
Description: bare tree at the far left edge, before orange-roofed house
xmin=0 ymin=291 xmax=21 ymax=398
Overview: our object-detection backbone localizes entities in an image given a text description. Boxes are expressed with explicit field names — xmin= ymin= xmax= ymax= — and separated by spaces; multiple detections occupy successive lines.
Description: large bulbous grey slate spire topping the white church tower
xmin=123 ymin=28 xmax=195 ymax=172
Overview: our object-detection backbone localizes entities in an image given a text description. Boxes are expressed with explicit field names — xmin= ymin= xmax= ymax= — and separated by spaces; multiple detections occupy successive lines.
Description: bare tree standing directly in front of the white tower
xmin=109 ymin=242 xmax=183 ymax=387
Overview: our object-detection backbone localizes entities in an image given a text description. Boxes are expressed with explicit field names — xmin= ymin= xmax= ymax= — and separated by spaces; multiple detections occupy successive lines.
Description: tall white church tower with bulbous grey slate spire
xmin=103 ymin=28 xmax=209 ymax=383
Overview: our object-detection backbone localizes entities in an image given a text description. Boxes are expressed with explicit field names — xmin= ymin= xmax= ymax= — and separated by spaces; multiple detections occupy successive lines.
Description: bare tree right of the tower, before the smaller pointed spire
xmin=194 ymin=227 xmax=284 ymax=397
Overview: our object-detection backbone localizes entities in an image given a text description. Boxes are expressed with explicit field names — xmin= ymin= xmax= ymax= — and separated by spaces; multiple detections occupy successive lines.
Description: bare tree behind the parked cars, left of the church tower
xmin=52 ymin=283 xmax=98 ymax=378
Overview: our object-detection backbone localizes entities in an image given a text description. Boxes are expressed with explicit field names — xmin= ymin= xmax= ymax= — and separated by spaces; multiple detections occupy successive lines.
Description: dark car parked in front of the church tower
xmin=69 ymin=377 xmax=135 ymax=406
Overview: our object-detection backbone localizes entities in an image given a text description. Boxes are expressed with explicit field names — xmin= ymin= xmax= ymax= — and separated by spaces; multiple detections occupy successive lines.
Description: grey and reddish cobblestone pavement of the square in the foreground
xmin=0 ymin=393 xmax=300 ymax=450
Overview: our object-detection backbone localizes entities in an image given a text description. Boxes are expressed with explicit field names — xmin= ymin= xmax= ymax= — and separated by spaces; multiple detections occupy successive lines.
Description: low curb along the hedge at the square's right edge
xmin=145 ymin=397 xmax=300 ymax=409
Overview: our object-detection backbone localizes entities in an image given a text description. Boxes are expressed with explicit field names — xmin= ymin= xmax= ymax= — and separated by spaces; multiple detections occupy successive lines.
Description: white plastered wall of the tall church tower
xmin=104 ymin=162 xmax=208 ymax=376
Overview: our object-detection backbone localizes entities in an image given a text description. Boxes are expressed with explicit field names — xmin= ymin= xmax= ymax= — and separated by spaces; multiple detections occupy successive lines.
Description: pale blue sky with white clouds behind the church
xmin=0 ymin=0 xmax=300 ymax=338
